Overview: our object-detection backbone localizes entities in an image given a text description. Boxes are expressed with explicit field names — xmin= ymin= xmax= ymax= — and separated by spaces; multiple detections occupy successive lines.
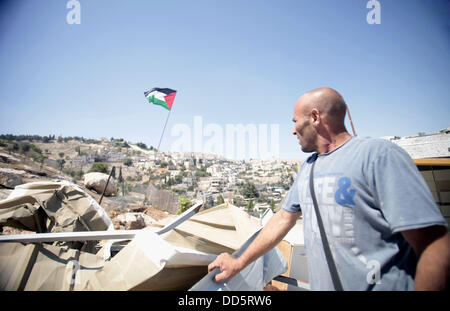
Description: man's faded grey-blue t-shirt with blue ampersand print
xmin=282 ymin=137 xmax=447 ymax=290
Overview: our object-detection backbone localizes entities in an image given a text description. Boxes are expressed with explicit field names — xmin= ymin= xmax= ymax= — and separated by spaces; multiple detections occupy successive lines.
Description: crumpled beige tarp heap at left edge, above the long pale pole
xmin=0 ymin=181 xmax=114 ymax=233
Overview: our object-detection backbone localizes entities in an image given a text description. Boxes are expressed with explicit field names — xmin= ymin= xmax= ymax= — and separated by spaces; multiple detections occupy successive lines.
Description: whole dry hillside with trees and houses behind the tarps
xmin=0 ymin=135 xmax=299 ymax=223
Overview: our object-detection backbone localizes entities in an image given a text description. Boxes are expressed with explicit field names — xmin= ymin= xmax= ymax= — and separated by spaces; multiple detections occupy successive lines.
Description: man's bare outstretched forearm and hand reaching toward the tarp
xmin=208 ymin=209 xmax=301 ymax=282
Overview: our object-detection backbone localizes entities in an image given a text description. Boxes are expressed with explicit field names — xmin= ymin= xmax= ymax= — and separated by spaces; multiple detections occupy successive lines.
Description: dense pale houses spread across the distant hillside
xmin=3 ymin=139 xmax=298 ymax=217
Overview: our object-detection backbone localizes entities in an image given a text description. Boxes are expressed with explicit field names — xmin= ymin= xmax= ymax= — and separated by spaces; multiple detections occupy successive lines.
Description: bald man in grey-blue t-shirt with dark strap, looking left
xmin=208 ymin=88 xmax=450 ymax=290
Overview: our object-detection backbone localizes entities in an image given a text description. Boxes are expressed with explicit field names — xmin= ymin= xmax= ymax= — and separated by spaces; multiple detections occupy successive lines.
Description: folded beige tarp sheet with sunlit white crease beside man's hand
xmin=86 ymin=203 xmax=268 ymax=290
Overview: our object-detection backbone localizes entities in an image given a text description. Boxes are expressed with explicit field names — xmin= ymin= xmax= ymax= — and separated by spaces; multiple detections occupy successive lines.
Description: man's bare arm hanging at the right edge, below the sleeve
xmin=402 ymin=226 xmax=450 ymax=290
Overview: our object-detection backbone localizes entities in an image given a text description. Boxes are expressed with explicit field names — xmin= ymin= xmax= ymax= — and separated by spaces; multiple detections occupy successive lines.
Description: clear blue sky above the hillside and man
xmin=0 ymin=0 xmax=450 ymax=159
